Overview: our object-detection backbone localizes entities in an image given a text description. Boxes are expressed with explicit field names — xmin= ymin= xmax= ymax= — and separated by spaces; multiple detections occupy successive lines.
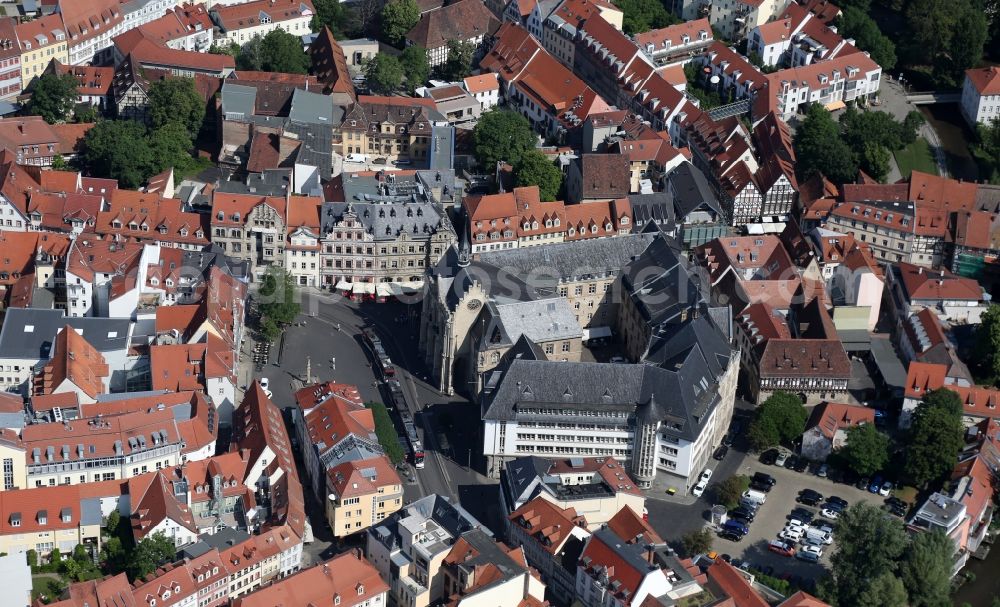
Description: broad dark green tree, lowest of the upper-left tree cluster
xmin=80 ymin=120 xmax=157 ymax=189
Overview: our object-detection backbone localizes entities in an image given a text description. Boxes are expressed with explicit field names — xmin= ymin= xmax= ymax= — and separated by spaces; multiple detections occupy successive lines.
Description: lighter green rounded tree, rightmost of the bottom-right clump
xmin=899 ymin=530 xmax=955 ymax=607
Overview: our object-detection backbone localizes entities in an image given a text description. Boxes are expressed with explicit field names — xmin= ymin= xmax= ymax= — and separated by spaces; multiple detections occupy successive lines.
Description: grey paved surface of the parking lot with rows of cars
xmin=709 ymin=457 xmax=884 ymax=579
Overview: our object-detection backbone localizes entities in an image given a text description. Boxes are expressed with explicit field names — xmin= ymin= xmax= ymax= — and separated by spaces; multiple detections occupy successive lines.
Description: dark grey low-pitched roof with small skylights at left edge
xmin=0 ymin=308 xmax=130 ymax=360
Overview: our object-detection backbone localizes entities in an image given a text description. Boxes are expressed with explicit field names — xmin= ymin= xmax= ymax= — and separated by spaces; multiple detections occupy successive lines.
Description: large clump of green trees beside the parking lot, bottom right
xmin=820 ymin=502 xmax=955 ymax=607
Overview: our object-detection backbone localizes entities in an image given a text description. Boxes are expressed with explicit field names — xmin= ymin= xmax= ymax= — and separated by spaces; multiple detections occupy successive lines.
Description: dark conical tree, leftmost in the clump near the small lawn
xmin=794 ymin=103 xmax=858 ymax=183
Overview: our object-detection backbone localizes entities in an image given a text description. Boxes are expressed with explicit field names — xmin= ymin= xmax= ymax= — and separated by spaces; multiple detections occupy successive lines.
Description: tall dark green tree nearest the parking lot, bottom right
xmin=830 ymin=502 xmax=907 ymax=606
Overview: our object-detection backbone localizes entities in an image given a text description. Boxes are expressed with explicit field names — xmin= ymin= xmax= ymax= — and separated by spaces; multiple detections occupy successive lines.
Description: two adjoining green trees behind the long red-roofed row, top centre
xmin=472 ymin=110 xmax=562 ymax=200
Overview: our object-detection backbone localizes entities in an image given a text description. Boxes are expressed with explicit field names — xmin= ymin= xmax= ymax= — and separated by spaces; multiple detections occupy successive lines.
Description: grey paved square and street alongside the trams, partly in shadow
xmin=254 ymin=291 xmax=499 ymax=554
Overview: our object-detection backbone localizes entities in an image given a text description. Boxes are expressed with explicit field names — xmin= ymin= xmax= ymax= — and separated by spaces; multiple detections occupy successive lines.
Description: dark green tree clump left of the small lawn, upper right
xmin=794 ymin=104 xmax=924 ymax=183
